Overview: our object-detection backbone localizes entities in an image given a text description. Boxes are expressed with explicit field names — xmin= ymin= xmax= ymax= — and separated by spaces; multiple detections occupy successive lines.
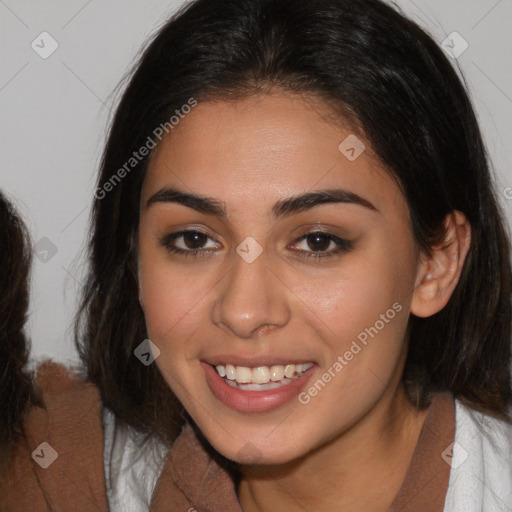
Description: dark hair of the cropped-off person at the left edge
xmin=0 ymin=192 xmax=39 ymax=463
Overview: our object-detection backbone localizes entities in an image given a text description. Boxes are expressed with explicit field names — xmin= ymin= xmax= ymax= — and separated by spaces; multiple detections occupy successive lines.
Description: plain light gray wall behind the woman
xmin=0 ymin=0 xmax=512 ymax=363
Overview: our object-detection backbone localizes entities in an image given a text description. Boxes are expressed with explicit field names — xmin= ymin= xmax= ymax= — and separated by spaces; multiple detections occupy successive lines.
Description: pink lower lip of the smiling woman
xmin=201 ymin=361 xmax=316 ymax=412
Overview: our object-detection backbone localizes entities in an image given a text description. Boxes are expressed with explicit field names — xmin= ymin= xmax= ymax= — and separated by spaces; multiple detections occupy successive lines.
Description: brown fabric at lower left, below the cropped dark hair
xmin=0 ymin=361 xmax=108 ymax=512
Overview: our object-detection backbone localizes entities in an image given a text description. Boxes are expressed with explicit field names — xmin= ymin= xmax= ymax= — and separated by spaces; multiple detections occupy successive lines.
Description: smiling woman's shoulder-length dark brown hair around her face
xmin=77 ymin=0 xmax=512 ymax=442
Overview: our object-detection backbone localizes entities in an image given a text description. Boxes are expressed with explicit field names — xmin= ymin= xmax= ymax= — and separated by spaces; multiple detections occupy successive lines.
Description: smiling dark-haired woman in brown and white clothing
xmin=2 ymin=0 xmax=512 ymax=512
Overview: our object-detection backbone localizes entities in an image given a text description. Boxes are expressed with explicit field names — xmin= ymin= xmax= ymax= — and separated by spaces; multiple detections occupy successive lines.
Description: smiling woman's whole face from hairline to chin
xmin=139 ymin=92 xmax=419 ymax=463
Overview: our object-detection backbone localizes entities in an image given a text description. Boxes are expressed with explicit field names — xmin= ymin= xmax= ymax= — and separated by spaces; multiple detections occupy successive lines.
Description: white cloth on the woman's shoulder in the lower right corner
xmin=445 ymin=400 xmax=512 ymax=512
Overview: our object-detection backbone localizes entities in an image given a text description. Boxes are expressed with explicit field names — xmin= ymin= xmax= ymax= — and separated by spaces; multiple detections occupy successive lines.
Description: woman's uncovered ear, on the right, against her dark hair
xmin=411 ymin=210 xmax=471 ymax=317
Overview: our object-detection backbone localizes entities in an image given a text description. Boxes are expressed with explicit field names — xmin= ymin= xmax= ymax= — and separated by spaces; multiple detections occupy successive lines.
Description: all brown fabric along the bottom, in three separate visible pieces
xmin=0 ymin=362 xmax=455 ymax=512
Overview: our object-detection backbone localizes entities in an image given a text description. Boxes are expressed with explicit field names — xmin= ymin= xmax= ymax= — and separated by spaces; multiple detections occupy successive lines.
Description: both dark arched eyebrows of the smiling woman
xmin=146 ymin=187 xmax=379 ymax=219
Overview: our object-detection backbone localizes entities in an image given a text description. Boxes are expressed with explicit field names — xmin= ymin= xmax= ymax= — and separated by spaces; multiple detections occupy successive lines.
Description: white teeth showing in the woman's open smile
xmin=214 ymin=363 xmax=313 ymax=391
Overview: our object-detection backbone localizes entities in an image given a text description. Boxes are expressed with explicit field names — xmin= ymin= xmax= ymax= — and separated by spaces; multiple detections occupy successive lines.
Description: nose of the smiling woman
xmin=212 ymin=249 xmax=290 ymax=338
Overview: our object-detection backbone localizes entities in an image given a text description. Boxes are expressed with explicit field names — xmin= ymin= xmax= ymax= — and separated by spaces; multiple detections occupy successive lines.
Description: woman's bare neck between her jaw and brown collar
xmin=238 ymin=383 xmax=427 ymax=512
